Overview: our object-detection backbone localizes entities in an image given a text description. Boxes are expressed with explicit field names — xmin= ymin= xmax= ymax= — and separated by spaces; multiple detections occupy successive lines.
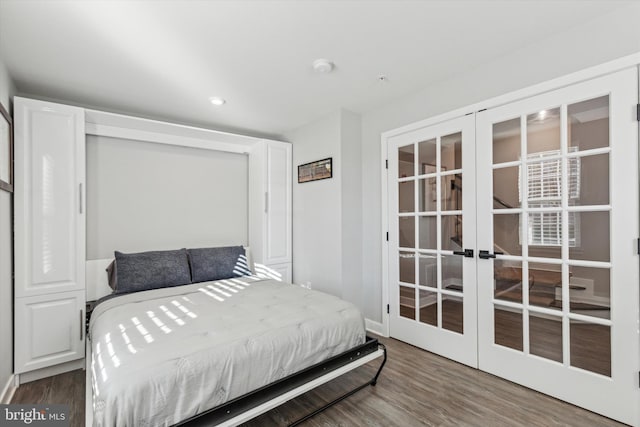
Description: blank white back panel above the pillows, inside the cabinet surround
xmin=87 ymin=135 xmax=248 ymax=259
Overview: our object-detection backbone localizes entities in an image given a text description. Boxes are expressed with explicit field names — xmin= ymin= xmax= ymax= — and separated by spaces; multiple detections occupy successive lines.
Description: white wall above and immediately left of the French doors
xmin=362 ymin=3 xmax=640 ymax=321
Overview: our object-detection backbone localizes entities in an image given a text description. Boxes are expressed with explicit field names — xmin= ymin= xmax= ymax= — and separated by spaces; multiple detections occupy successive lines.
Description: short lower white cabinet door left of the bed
xmin=15 ymin=291 xmax=85 ymax=374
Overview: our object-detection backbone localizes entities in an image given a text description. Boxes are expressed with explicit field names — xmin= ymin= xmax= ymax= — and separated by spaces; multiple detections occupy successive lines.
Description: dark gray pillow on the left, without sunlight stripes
xmin=115 ymin=249 xmax=191 ymax=294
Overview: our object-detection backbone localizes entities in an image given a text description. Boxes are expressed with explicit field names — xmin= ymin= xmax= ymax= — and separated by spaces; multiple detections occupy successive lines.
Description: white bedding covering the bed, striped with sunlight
xmin=90 ymin=278 xmax=365 ymax=426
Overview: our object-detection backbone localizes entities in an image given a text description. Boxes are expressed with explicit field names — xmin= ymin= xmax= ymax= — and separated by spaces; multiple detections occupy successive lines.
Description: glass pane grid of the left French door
xmin=397 ymin=132 xmax=464 ymax=334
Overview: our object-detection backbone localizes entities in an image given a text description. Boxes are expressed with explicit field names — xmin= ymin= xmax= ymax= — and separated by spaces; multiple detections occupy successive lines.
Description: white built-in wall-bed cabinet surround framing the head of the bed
xmin=14 ymin=97 xmax=292 ymax=380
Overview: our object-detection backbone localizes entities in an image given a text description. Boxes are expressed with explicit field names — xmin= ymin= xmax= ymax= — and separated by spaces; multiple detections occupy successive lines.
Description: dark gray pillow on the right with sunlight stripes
xmin=187 ymin=246 xmax=251 ymax=283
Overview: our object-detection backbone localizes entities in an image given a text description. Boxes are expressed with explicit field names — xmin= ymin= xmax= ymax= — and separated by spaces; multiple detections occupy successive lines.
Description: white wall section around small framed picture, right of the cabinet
xmin=285 ymin=110 xmax=363 ymax=307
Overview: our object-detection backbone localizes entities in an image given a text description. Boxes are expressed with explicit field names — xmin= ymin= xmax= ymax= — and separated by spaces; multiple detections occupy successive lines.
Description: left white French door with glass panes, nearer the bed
xmin=388 ymin=115 xmax=477 ymax=366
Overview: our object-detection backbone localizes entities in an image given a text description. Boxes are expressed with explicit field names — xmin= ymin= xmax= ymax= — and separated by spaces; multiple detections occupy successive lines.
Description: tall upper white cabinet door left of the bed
xmin=14 ymin=98 xmax=85 ymax=297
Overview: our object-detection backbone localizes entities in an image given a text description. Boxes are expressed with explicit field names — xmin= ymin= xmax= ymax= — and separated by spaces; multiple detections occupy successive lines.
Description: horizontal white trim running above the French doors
xmin=381 ymin=52 xmax=640 ymax=143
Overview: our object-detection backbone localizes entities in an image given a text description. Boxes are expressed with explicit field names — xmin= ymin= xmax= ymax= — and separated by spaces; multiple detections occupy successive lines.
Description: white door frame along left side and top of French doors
xmin=380 ymin=52 xmax=640 ymax=337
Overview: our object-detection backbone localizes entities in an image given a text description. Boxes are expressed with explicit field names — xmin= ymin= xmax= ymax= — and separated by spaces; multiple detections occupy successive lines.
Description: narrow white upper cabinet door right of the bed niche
xmin=264 ymin=141 xmax=291 ymax=264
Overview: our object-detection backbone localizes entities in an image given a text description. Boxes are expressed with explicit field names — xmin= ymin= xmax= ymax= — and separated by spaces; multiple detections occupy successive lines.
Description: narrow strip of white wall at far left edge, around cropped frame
xmin=0 ymin=58 xmax=15 ymax=403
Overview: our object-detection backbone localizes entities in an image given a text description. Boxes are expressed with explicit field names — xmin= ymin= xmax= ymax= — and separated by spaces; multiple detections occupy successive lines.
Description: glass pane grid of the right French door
xmin=492 ymin=96 xmax=613 ymax=376
